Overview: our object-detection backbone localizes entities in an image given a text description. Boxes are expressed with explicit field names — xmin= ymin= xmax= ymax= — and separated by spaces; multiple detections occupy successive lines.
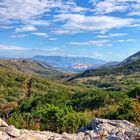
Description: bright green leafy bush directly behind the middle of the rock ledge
xmin=32 ymin=104 xmax=85 ymax=133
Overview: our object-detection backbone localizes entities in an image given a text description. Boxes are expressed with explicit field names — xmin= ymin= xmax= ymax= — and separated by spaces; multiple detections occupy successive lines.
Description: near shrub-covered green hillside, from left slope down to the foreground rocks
xmin=0 ymin=61 xmax=140 ymax=133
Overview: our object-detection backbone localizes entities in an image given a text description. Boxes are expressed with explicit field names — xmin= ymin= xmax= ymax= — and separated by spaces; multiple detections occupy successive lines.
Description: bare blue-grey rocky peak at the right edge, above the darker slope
xmin=119 ymin=51 xmax=140 ymax=66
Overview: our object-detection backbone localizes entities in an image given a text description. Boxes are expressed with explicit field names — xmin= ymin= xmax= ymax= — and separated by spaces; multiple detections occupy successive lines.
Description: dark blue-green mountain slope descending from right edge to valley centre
xmin=69 ymin=52 xmax=140 ymax=80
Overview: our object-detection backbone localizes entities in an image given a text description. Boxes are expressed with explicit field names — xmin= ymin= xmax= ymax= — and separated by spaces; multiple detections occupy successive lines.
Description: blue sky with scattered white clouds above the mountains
xmin=0 ymin=0 xmax=140 ymax=61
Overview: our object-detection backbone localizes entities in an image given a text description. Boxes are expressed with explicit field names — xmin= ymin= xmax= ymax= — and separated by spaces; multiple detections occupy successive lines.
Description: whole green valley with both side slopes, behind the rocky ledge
xmin=0 ymin=50 xmax=140 ymax=136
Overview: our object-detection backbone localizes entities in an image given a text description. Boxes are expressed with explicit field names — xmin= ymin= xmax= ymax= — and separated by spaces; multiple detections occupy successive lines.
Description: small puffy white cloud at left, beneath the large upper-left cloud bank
xmin=16 ymin=25 xmax=37 ymax=32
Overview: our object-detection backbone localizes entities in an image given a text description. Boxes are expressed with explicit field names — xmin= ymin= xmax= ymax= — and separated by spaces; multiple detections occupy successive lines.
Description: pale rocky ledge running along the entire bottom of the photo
xmin=0 ymin=118 xmax=140 ymax=140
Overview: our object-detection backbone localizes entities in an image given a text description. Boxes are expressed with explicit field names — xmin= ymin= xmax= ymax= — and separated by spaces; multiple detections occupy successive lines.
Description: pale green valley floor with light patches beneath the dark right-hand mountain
xmin=74 ymin=72 xmax=140 ymax=92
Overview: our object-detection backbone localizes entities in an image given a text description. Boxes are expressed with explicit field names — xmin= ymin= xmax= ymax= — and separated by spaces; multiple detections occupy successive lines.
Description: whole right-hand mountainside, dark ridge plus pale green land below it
xmin=68 ymin=50 xmax=140 ymax=91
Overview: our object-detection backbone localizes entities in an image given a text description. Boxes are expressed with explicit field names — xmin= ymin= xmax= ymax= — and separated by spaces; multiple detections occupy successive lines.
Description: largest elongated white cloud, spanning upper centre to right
xmin=54 ymin=14 xmax=135 ymax=34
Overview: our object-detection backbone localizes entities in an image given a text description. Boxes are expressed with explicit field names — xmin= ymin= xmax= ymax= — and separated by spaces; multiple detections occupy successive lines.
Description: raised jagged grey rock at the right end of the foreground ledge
xmin=86 ymin=118 xmax=137 ymax=140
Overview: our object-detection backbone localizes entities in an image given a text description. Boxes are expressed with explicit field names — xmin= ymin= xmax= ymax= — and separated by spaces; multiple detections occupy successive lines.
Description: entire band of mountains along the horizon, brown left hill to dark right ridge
xmin=0 ymin=52 xmax=140 ymax=80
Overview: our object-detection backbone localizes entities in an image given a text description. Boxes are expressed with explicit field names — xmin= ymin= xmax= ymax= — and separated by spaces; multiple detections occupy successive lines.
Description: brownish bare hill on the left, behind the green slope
xmin=0 ymin=59 xmax=64 ymax=79
